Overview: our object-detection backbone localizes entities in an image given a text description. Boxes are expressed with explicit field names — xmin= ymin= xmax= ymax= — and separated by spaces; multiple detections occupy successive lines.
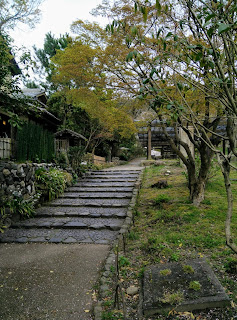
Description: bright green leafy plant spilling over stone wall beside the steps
xmin=35 ymin=168 xmax=72 ymax=200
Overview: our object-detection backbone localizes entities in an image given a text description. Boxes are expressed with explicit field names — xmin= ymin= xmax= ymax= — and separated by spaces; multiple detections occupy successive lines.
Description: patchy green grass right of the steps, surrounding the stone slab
xmin=101 ymin=160 xmax=237 ymax=320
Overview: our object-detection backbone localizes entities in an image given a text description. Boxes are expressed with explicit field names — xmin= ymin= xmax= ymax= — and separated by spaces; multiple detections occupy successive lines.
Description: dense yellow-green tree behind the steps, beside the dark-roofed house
xmin=48 ymin=40 xmax=135 ymax=154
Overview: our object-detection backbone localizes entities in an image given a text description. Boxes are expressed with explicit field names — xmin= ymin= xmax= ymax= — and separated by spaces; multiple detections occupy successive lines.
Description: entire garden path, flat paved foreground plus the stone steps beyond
xmin=0 ymin=160 xmax=141 ymax=320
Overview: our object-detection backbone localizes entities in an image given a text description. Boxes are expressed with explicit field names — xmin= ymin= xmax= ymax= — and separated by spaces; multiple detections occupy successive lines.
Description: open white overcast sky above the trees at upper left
xmin=11 ymin=0 xmax=106 ymax=49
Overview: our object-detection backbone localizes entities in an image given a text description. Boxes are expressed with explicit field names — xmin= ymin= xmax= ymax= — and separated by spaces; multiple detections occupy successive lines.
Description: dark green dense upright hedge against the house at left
xmin=16 ymin=121 xmax=54 ymax=162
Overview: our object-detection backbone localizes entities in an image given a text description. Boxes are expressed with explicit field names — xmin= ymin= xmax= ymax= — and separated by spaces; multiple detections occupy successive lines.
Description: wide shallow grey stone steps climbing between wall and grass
xmin=0 ymin=170 xmax=140 ymax=244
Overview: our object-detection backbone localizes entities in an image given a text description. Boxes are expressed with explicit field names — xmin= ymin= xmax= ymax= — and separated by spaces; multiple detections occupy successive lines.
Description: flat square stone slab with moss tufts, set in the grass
xmin=143 ymin=259 xmax=230 ymax=316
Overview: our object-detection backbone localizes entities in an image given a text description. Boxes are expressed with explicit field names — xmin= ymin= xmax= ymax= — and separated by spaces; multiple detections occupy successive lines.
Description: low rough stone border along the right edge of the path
xmin=94 ymin=167 xmax=145 ymax=320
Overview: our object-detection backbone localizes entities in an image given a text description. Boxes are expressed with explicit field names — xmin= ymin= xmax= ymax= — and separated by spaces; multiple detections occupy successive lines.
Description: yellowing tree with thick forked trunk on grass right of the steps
xmin=87 ymin=0 xmax=221 ymax=205
